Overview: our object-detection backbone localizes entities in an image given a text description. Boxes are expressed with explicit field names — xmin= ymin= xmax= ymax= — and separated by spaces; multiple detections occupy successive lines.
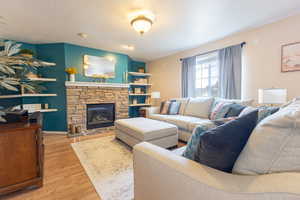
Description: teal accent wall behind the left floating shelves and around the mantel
xmin=0 ymin=40 xmax=146 ymax=131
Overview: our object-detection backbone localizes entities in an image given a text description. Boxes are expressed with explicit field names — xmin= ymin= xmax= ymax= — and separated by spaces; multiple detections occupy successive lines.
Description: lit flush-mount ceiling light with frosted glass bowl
xmin=130 ymin=11 xmax=154 ymax=35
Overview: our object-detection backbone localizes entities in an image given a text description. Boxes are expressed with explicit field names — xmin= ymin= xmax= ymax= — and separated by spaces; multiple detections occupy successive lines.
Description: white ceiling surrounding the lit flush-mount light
xmin=0 ymin=0 xmax=300 ymax=61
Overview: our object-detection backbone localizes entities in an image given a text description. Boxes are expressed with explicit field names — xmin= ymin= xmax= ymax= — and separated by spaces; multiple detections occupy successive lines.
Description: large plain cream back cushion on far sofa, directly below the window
xmin=184 ymin=97 xmax=214 ymax=119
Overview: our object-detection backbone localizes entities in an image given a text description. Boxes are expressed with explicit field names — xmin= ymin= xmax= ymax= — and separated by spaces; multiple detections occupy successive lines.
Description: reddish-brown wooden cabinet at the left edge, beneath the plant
xmin=0 ymin=123 xmax=44 ymax=195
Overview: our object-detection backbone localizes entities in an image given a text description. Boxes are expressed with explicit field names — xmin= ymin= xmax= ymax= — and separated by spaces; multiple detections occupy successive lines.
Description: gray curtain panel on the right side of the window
xmin=219 ymin=44 xmax=242 ymax=99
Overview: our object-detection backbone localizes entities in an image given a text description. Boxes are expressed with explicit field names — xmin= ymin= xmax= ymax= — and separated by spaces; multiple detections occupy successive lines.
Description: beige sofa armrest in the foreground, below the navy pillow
xmin=133 ymin=142 xmax=300 ymax=200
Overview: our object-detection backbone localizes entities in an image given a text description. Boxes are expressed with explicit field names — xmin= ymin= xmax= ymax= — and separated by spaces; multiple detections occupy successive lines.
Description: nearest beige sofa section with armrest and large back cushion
xmin=134 ymin=99 xmax=300 ymax=200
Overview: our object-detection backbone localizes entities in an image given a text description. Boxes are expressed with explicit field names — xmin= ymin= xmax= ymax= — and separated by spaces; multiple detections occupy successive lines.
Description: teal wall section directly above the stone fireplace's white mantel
xmin=65 ymin=44 xmax=129 ymax=83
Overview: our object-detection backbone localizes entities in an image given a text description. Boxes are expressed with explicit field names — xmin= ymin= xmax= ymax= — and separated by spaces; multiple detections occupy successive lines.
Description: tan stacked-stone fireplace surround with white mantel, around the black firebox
xmin=66 ymin=83 xmax=128 ymax=134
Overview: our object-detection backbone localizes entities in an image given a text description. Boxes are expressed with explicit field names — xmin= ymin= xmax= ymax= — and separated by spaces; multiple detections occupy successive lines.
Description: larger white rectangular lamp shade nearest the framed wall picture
xmin=258 ymin=88 xmax=287 ymax=104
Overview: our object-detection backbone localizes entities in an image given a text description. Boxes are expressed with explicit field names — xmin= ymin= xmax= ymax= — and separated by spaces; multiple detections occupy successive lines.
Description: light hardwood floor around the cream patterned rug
xmin=0 ymin=132 xmax=184 ymax=200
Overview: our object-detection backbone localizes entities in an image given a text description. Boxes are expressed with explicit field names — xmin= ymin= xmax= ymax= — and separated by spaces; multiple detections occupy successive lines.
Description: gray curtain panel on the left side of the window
xmin=181 ymin=56 xmax=196 ymax=97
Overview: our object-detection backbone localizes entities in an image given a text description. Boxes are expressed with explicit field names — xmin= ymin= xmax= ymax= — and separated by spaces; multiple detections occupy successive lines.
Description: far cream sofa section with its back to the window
xmin=146 ymin=97 xmax=253 ymax=142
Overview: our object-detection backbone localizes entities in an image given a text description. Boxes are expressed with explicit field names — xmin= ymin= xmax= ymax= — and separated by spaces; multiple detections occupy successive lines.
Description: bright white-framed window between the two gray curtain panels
xmin=196 ymin=52 xmax=219 ymax=97
